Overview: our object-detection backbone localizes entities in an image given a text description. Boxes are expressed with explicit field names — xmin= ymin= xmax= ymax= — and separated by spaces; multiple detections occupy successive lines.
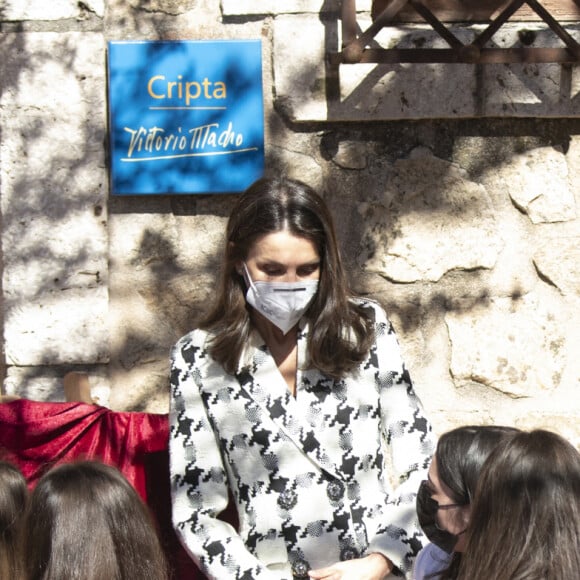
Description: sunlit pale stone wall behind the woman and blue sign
xmin=0 ymin=0 xmax=580 ymax=443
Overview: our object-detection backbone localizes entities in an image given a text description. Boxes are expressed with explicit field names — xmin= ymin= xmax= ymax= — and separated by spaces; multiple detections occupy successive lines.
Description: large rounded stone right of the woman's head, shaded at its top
xmin=359 ymin=150 xmax=502 ymax=283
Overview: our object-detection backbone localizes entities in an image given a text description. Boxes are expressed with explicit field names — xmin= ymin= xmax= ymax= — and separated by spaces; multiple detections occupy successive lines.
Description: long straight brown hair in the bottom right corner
xmin=459 ymin=429 xmax=580 ymax=580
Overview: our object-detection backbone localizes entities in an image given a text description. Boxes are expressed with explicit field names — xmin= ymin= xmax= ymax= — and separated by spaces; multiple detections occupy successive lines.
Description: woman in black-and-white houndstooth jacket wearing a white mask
xmin=170 ymin=178 xmax=433 ymax=580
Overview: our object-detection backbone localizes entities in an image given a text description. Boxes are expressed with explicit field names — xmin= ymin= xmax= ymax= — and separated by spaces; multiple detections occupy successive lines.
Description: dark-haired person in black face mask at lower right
xmin=413 ymin=425 xmax=518 ymax=580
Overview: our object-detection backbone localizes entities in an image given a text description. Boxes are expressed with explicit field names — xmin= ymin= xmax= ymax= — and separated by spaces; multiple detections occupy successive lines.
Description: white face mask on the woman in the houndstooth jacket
xmin=244 ymin=264 xmax=318 ymax=334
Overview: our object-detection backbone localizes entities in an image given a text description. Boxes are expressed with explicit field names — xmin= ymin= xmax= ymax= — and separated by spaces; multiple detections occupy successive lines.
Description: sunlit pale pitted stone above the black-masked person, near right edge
xmin=445 ymin=287 xmax=574 ymax=399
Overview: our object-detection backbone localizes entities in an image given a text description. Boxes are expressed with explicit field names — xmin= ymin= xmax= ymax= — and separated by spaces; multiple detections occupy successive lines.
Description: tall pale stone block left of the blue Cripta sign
xmin=0 ymin=33 xmax=109 ymax=366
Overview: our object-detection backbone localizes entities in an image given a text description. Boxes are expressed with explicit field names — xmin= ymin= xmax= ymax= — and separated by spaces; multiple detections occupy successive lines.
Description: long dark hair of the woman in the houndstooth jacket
xmin=200 ymin=178 xmax=374 ymax=378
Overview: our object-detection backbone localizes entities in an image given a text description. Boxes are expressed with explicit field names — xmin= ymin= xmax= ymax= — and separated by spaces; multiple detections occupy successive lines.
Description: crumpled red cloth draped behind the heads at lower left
xmin=0 ymin=399 xmax=203 ymax=580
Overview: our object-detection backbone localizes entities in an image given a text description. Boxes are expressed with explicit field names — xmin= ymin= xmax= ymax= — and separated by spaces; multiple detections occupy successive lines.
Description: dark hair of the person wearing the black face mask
xmin=435 ymin=425 xmax=519 ymax=580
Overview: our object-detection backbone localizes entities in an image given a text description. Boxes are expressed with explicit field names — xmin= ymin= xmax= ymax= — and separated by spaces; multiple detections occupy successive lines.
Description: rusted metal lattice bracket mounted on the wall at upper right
xmin=328 ymin=0 xmax=580 ymax=65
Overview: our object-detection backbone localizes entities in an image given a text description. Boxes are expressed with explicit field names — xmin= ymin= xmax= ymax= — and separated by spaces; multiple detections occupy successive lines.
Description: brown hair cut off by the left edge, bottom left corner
xmin=0 ymin=461 xmax=28 ymax=580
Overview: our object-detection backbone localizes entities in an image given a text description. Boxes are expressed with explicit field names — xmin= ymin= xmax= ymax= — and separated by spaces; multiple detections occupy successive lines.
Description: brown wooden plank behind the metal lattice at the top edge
xmin=372 ymin=0 xmax=580 ymax=23
